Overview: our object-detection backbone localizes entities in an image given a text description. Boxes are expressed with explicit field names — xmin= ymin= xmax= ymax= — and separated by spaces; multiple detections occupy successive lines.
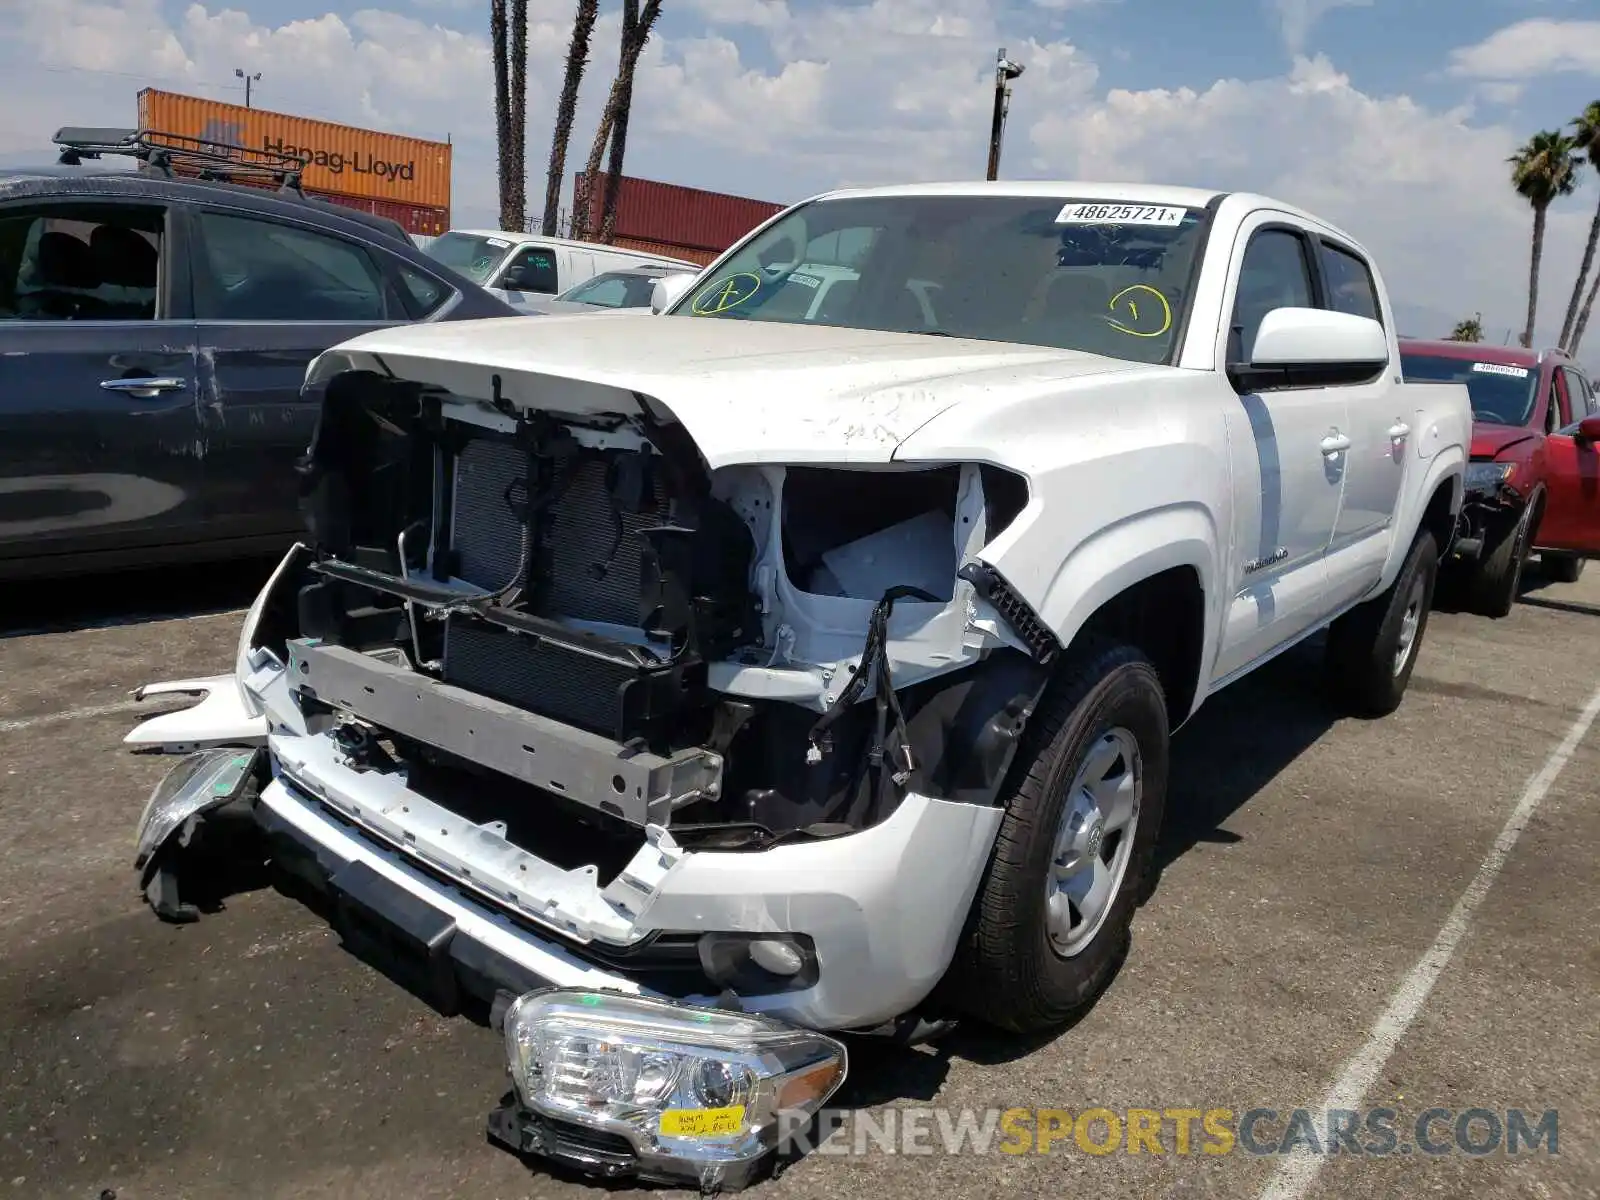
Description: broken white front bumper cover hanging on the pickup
xmin=258 ymin=738 xmax=1002 ymax=1030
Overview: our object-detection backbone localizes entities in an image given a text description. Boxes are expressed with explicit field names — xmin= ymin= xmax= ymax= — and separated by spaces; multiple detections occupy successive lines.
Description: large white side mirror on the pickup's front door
xmin=1229 ymin=309 xmax=1389 ymax=390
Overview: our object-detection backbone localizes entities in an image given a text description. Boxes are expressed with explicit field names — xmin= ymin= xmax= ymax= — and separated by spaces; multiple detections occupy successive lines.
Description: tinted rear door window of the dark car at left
xmin=195 ymin=213 xmax=390 ymax=322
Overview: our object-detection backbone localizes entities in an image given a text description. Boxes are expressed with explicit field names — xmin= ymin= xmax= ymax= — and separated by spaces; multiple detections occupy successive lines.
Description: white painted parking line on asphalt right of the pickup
xmin=1259 ymin=690 xmax=1600 ymax=1200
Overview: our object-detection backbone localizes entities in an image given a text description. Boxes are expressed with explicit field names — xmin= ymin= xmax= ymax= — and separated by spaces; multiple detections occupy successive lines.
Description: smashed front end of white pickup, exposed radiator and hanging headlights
xmin=130 ymin=336 xmax=1058 ymax=1189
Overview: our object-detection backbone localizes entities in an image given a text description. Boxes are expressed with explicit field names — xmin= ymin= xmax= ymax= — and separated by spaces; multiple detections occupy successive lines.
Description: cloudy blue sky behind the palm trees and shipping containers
xmin=0 ymin=0 xmax=1594 ymax=352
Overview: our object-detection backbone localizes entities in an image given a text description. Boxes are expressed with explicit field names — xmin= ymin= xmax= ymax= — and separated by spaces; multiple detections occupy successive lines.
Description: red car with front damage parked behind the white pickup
xmin=1400 ymin=338 xmax=1600 ymax=616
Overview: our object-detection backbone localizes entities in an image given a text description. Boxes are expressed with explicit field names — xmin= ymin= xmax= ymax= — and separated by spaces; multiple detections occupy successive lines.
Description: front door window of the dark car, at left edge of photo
xmin=0 ymin=203 xmax=166 ymax=322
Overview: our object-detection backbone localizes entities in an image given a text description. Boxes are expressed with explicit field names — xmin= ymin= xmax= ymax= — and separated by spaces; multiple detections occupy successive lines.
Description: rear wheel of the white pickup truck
xmin=1323 ymin=530 xmax=1438 ymax=717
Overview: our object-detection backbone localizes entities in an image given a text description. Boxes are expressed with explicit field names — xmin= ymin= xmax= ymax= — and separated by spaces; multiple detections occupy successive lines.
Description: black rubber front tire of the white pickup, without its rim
xmin=944 ymin=638 xmax=1168 ymax=1034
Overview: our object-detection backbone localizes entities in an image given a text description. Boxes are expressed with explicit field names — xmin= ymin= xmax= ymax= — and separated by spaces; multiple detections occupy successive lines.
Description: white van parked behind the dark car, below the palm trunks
xmin=424 ymin=229 xmax=701 ymax=312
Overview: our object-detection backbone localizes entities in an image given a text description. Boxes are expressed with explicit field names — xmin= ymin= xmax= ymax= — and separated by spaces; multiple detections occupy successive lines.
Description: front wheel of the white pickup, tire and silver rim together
xmin=949 ymin=642 xmax=1168 ymax=1032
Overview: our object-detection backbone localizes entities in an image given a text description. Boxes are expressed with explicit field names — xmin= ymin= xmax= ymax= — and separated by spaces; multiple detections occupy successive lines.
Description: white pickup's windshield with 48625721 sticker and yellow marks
xmin=674 ymin=195 xmax=1206 ymax=363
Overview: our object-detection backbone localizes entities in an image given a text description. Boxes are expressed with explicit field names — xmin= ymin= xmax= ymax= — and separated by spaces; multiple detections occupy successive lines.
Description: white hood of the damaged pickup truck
xmin=318 ymin=315 xmax=1150 ymax=470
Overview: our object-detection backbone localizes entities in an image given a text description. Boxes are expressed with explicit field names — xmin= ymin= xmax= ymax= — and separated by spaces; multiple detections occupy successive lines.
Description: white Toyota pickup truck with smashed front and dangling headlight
xmin=128 ymin=182 xmax=1472 ymax=1187
